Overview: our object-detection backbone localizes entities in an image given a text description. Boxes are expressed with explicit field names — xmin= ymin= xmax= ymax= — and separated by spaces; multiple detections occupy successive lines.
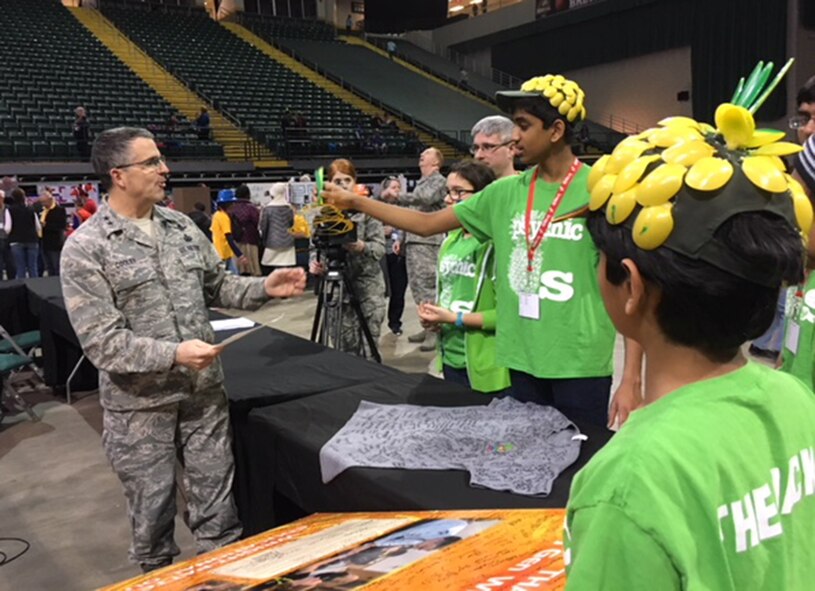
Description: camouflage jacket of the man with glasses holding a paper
xmin=60 ymin=203 xmax=269 ymax=410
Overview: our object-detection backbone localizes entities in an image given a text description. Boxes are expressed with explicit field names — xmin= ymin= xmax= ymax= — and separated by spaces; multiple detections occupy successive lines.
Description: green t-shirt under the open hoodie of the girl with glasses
xmin=438 ymin=230 xmax=488 ymax=369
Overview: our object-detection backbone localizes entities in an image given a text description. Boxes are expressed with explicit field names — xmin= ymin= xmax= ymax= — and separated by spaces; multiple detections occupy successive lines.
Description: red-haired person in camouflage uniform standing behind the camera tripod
xmin=310 ymin=159 xmax=385 ymax=358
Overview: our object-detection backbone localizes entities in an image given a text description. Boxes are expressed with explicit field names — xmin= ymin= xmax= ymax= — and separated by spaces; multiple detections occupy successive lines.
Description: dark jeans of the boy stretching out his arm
xmin=509 ymin=369 xmax=611 ymax=427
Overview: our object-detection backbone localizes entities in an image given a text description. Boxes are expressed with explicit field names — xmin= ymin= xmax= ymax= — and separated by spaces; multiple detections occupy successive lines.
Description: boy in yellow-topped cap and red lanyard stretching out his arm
xmin=324 ymin=75 xmax=642 ymax=425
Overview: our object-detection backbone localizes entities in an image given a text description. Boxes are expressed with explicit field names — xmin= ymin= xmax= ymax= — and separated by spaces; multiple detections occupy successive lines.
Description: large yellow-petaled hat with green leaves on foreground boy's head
xmin=588 ymin=60 xmax=813 ymax=286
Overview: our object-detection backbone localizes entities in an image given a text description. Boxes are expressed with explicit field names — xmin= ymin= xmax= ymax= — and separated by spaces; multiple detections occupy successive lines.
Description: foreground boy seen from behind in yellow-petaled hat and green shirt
xmin=564 ymin=82 xmax=815 ymax=591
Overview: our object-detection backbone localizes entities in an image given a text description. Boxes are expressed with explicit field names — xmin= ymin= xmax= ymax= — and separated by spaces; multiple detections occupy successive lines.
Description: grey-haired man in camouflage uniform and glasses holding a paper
xmin=61 ymin=128 xmax=305 ymax=571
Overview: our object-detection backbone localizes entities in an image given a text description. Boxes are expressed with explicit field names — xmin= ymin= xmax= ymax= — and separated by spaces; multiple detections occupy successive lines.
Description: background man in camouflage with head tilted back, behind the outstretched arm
xmin=383 ymin=148 xmax=447 ymax=351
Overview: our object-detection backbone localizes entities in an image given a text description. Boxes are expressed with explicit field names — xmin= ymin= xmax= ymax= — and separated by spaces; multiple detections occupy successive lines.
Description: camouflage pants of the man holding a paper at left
xmin=102 ymin=389 xmax=241 ymax=570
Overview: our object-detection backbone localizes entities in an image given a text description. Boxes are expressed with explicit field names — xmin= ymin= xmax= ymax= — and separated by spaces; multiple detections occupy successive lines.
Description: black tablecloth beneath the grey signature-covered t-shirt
xmin=238 ymin=374 xmax=613 ymax=533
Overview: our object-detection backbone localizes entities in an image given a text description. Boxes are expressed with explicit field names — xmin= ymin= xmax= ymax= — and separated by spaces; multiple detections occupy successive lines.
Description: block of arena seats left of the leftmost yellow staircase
xmin=0 ymin=0 xmax=223 ymax=160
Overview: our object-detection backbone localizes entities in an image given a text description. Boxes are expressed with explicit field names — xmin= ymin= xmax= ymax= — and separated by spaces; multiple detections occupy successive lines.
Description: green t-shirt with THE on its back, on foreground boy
xmin=564 ymin=363 xmax=815 ymax=591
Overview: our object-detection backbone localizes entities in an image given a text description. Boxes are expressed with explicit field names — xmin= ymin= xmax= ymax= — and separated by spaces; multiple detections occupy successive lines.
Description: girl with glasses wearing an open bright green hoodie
xmin=419 ymin=160 xmax=509 ymax=394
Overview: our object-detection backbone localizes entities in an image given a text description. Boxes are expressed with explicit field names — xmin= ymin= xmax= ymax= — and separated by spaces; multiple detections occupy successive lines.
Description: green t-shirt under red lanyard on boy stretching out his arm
xmin=454 ymin=166 xmax=615 ymax=378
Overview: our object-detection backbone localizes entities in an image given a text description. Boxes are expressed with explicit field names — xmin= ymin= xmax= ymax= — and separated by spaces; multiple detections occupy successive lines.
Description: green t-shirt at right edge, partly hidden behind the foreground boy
xmin=781 ymin=273 xmax=815 ymax=390
